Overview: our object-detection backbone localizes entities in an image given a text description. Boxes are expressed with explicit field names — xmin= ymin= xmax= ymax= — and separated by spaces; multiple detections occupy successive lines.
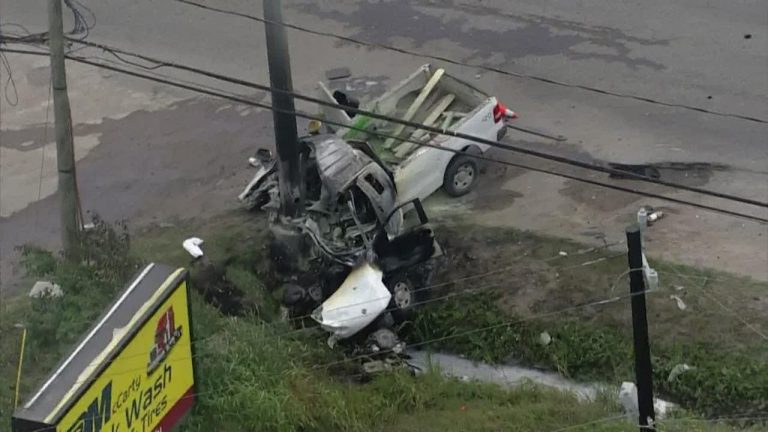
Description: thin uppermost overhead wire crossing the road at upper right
xmin=176 ymin=0 xmax=768 ymax=123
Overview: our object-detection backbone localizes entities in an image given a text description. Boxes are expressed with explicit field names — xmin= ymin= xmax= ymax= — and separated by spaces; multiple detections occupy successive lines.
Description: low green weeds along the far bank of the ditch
xmin=410 ymin=295 xmax=768 ymax=416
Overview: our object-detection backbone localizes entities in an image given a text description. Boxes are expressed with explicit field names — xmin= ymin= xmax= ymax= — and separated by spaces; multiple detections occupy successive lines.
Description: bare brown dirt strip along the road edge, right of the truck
xmin=433 ymin=221 xmax=768 ymax=358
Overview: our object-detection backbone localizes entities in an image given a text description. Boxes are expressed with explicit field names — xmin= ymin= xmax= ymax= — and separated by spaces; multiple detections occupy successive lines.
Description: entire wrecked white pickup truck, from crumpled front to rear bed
xmin=239 ymin=65 xmax=516 ymax=365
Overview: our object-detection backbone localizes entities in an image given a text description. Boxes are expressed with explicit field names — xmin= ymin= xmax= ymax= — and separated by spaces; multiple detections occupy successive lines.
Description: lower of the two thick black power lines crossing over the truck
xmin=0 ymin=48 xmax=768 ymax=224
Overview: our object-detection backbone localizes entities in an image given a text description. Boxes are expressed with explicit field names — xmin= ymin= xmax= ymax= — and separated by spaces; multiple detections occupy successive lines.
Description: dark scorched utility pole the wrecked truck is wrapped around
xmin=264 ymin=0 xmax=304 ymax=218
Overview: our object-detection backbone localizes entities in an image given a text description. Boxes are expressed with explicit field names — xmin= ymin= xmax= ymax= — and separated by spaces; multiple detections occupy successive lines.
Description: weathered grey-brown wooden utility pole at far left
xmin=48 ymin=0 xmax=82 ymax=256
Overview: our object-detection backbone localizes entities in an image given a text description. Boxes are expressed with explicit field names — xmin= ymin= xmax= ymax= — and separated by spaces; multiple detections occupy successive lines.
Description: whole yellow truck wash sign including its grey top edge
xmin=12 ymin=264 xmax=195 ymax=432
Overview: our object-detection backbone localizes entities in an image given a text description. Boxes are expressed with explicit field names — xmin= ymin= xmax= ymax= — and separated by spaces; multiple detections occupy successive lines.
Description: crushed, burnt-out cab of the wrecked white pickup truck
xmin=239 ymin=135 xmax=439 ymax=306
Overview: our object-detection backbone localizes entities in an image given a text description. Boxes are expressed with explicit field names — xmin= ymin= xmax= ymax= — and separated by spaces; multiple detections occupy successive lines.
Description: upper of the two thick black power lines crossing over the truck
xmin=22 ymin=37 xmax=768 ymax=208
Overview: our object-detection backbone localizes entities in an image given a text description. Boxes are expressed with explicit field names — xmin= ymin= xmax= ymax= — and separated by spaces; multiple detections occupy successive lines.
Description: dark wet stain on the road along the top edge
xmin=291 ymin=0 xmax=668 ymax=70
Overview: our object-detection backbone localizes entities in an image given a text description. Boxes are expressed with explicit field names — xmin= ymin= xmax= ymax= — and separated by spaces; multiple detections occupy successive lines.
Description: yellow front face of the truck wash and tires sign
xmin=51 ymin=279 xmax=194 ymax=432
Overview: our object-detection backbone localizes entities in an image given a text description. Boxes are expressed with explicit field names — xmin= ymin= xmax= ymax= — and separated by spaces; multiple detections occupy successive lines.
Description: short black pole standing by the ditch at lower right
xmin=626 ymin=226 xmax=656 ymax=432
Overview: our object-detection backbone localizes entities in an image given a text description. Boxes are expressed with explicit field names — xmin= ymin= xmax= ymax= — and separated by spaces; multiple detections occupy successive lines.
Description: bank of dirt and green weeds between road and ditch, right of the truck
xmin=409 ymin=225 xmax=768 ymax=416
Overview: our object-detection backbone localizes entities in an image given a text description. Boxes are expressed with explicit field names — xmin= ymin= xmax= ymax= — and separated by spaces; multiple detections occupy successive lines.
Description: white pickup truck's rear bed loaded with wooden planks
xmin=319 ymin=64 xmax=517 ymax=202
